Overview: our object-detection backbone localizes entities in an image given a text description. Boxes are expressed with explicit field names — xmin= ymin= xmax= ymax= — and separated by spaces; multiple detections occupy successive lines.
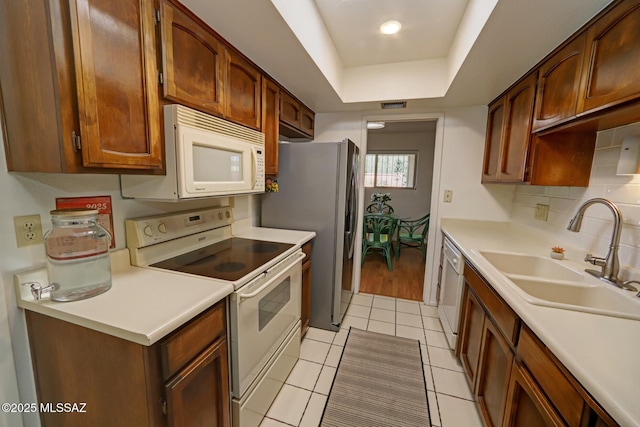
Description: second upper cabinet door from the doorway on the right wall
xmin=498 ymin=73 xmax=536 ymax=182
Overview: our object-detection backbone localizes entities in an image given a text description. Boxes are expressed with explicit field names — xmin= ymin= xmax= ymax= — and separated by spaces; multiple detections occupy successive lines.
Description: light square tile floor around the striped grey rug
xmin=260 ymin=294 xmax=482 ymax=427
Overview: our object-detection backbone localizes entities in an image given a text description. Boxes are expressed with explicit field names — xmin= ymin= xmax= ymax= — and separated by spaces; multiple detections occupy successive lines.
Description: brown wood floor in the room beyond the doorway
xmin=360 ymin=247 xmax=425 ymax=301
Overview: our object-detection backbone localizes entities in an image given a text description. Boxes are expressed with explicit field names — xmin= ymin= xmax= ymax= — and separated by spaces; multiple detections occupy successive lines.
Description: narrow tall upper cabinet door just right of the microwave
xmin=262 ymin=78 xmax=280 ymax=176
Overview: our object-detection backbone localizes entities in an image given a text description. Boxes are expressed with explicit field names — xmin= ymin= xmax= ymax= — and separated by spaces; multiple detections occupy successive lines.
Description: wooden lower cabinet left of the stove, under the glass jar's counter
xmin=26 ymin=301 xmax=231 ymax=427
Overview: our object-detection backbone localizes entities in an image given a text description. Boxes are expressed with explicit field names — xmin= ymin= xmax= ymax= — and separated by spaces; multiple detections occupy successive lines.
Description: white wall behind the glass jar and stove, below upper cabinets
xmin=0 ymin=115 xmax=259 ymax=427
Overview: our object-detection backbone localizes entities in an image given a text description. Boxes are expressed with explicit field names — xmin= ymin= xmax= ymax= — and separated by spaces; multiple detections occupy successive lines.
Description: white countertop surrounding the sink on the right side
xmin=441 ymin=219 xmax=640 ymax=426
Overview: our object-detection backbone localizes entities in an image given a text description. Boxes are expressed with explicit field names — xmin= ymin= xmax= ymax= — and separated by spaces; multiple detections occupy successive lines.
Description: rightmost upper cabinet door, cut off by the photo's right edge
xmin=578 ymin=0 xmax=640 ymax=113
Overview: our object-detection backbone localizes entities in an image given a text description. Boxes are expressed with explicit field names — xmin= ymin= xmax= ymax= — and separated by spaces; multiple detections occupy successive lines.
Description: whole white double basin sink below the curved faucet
xmin=480 ymin=251 xmax=640 ymax=320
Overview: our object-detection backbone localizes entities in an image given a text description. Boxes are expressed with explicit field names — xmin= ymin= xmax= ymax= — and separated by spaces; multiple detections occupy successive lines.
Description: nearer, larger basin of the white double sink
xmin=508 ymin=276 xmax=640 ymax=320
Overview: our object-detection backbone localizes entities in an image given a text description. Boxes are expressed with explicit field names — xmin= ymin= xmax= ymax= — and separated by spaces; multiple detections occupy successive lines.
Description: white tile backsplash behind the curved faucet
xmin=512 ymin=123 xmax=640 ymax=279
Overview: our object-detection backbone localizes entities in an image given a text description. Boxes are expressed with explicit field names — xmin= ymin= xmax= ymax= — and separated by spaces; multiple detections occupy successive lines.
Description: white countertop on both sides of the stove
xmin=14 ymin=227 xmax=315 ymax=346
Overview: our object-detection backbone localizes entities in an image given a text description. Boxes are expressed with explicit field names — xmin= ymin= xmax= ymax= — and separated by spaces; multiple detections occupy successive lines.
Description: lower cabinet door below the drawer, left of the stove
xmin=165 ymin=338 xmax=230 ymax=427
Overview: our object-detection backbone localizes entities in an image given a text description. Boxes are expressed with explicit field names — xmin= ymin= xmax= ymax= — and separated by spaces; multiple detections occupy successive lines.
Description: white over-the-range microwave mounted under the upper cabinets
xmin=120 ymin=104 xmax=265 ymax=201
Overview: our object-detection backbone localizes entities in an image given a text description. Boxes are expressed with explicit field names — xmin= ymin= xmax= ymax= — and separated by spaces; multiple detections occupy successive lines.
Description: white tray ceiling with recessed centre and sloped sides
xmin=183 ymin=0 xmax=611 ymax=112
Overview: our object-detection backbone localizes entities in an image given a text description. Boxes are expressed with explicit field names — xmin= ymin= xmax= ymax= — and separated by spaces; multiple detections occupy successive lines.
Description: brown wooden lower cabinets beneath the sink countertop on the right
xmin=456 ymin=263 xmax=618 ymax=427
